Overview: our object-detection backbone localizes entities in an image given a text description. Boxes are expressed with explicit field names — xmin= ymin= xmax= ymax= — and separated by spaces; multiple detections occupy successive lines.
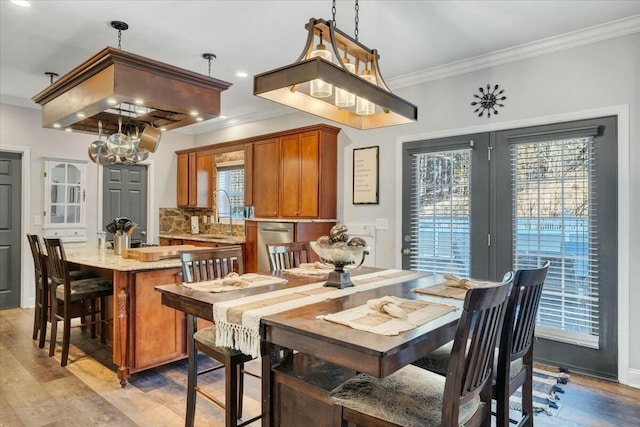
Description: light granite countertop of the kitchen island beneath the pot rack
xmin=64 ymin=243 xmax=202 ymax=271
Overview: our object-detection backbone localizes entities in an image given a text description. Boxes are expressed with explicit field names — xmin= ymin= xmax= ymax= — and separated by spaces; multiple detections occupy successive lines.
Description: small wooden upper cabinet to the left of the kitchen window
xmin=176 ymin=152 xmax=213 ymax=208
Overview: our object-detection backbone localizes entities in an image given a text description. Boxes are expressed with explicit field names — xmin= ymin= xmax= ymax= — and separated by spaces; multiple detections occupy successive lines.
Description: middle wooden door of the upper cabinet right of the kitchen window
xmin=280 ymin=135 xmax=301 ymax=217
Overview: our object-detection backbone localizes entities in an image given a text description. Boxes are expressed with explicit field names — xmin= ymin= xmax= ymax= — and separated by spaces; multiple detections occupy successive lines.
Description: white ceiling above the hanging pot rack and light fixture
xmin=0 ymin=0 xmax=640 ymax=134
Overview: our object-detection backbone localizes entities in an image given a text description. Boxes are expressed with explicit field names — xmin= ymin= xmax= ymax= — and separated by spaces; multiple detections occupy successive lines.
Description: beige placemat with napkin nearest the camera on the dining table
xmin=316 ymin=297 xmax=458 ymax=335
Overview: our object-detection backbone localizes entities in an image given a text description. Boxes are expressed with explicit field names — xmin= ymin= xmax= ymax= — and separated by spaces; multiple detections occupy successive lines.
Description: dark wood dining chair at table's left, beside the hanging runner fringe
xmin=180 ymin=246 xmax=261 ymax=427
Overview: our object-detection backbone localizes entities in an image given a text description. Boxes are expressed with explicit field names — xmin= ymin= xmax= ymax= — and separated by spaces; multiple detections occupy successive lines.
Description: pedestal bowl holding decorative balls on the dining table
xmin=311 ymin=242 xmax=369 ymax=289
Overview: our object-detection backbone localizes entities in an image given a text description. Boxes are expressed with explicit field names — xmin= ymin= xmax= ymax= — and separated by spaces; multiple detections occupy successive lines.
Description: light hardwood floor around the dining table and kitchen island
xmin=0 ymin=309 xmax=640 ymax=427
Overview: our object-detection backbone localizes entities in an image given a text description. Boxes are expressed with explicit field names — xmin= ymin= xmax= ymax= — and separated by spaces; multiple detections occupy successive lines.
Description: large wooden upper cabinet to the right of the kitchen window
xmin=252 ymin=125 xmax=340 ymax=219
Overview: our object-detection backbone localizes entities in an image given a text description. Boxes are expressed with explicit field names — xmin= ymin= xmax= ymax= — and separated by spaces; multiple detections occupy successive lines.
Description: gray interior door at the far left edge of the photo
xmin=0 ymin=151 xmax=22 ymax=309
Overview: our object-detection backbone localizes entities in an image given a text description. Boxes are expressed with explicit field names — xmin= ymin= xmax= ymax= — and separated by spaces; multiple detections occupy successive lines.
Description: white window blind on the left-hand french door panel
xmin=409 ymin=149 xmax=471 ymax=277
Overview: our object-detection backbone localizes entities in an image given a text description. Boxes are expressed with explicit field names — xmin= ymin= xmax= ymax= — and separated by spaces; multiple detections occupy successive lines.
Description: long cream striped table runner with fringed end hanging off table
xmin=213 ymin=270 xmax=425 ymax=357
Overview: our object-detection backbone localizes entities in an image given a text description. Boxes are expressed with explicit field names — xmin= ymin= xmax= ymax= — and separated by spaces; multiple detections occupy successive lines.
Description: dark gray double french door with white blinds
xmin=403 ymin=118 xmax=617 ymax=379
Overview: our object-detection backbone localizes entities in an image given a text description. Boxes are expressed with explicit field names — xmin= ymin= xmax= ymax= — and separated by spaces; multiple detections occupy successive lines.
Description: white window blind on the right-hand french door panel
xmin=511 ymin=137 xmax=599 ymax=348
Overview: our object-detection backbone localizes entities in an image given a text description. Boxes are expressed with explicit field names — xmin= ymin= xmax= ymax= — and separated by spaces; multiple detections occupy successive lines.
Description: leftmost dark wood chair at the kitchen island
xmin=27 ymin=233 xmax=95 ymax=348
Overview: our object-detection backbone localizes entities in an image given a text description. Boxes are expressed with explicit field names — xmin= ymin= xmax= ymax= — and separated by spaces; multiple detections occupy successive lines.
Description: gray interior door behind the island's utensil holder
xmin=102 ymin=164 xmax=147 ymax=243
